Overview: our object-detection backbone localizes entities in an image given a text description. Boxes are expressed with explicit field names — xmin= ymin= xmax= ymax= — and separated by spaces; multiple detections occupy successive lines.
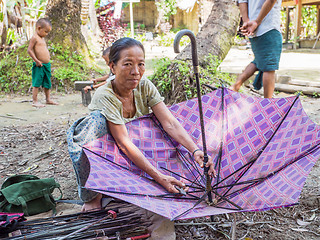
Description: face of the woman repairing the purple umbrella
xmin=109 ymin=46 xmax=145 ymax=89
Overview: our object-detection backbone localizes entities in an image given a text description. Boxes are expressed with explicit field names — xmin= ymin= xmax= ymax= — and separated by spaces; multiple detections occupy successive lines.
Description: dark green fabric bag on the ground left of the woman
xmin=0 ymin=175 xmax=62 ymax=216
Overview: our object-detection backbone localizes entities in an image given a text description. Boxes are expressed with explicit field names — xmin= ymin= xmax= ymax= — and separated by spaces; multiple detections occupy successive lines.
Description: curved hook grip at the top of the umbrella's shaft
xmin=173 ymin=29 xmax=199 ymax=73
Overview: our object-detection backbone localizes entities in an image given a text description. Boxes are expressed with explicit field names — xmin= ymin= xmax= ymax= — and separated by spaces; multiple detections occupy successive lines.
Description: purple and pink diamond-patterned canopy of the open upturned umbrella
xmin=83 ymin=88 xmax=320 ymax=219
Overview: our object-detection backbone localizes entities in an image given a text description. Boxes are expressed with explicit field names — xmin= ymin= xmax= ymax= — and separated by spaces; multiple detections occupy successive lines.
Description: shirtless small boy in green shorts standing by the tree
xmin=28 ymin=18 xmax=58 ymax=107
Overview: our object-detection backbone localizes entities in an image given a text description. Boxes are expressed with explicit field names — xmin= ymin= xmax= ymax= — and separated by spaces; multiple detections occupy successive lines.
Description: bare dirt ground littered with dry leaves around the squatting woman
xmin=0 ymin=46 xmax=320 ymax=240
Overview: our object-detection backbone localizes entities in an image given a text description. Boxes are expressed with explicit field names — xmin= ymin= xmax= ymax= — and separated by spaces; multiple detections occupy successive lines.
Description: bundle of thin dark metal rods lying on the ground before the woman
xmin=7 ymin=202 xmax=149 ymax=240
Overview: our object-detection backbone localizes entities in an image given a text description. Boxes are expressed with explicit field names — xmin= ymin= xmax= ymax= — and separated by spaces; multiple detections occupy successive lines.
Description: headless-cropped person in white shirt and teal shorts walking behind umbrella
xmin=231 ymin=0 xmax=282 ymax=98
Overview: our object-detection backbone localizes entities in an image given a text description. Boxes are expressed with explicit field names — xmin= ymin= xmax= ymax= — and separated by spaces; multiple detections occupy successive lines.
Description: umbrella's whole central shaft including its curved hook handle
xmin=173 ymin=29 xmax=212 ymax=202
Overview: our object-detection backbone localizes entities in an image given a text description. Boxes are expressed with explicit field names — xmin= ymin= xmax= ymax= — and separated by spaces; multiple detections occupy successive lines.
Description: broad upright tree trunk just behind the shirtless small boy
xmin=46 ymin=0 xmax=91 ymax=63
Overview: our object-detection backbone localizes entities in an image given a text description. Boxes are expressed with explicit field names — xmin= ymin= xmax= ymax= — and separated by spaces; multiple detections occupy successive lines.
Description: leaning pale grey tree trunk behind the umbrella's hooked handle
xmin=176 ymin=0 xmax=240 ymax=66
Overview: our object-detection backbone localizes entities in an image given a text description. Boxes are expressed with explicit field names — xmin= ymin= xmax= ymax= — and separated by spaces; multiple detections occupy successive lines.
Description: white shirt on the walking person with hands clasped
xmin=238 ymin=0 xmax=282 ymax=37
